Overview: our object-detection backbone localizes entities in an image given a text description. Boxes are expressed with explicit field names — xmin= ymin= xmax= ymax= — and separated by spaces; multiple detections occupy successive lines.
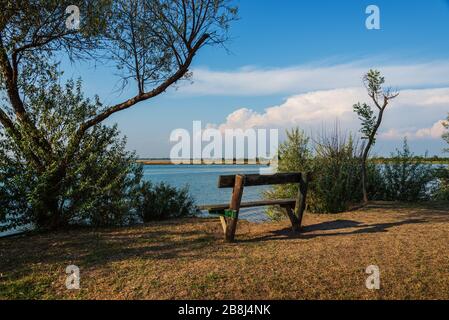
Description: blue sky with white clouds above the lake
xmin=63 ymin=0 xmax=449 ymax=158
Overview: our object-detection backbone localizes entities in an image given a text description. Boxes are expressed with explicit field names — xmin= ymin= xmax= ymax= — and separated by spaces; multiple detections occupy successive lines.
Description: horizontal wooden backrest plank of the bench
xmin=218 ymin=172 xmax=301 ymax=188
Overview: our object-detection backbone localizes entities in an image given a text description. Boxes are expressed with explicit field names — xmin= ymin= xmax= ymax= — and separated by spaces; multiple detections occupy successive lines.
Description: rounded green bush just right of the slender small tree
xmin=381 ymin=139 xmax=434 ymax=201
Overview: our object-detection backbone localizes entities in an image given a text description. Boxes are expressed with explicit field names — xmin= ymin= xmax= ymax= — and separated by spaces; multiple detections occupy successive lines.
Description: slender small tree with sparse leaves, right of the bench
xmin=353 ymin=70 xmax=399 ymax=203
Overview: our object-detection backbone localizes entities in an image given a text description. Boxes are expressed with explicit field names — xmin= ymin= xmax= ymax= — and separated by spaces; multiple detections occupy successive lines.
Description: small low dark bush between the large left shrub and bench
xmin=137 ymin=182 xmax=197 ymax=222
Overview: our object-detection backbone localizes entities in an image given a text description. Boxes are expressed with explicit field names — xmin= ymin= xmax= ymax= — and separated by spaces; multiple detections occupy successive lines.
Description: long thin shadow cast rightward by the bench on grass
xmin=238 ymin=219 xmax=427 ymax=243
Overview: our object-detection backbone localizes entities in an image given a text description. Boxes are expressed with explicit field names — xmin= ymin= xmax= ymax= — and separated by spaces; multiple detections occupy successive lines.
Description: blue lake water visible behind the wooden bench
xmin=144 ymin=165 xmax=268 ymax=222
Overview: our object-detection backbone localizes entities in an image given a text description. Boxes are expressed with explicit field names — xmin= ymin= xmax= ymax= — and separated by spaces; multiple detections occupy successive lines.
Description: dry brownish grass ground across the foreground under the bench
xmin=0 ymin=203 xmax=449 ymax=299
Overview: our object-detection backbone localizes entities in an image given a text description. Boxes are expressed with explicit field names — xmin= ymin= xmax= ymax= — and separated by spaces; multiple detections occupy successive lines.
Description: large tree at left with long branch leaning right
xmin=0 ymin=0 xmax=237 ymax=228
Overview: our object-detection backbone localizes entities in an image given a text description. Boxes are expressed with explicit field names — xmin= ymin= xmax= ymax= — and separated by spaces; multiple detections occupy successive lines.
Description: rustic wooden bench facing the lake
xmin=199 ymin=173 xmax=310 ymax=242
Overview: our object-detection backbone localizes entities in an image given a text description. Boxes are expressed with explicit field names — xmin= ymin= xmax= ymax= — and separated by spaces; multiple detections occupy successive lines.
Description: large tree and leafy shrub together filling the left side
xmin=0 ymin=0 xmax=223 ymax=229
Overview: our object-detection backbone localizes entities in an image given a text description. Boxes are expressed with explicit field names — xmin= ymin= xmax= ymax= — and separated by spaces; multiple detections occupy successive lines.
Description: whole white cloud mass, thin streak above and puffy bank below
xmin=178 ymin=60 xmax=449 ymax=144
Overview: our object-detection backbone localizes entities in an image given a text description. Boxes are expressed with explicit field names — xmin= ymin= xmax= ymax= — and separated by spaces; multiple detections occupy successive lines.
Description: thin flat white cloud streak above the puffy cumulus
xmin=177 ymin=61 xmax=449 ymax=96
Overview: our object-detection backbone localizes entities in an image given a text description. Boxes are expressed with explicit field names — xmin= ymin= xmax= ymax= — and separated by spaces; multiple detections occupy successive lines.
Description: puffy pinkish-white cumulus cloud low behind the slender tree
xmin=212 ymin=87 xmax=449 ymax=139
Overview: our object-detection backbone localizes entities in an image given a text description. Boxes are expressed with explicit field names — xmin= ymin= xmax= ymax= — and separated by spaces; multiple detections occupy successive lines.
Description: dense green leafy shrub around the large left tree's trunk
xmin=0 ymin=81 xmax=142 ymax=230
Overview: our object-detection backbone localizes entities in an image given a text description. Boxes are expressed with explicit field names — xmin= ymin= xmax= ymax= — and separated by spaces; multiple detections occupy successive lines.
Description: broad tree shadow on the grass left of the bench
xmin=0 ymin=220 xmax=218 ymax=274
